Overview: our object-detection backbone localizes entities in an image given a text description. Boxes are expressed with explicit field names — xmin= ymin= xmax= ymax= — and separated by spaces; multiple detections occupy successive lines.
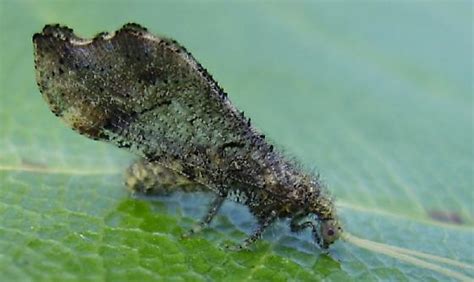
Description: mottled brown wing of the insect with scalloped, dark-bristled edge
xmin=33 ymin=24 xmax=275 ymax=186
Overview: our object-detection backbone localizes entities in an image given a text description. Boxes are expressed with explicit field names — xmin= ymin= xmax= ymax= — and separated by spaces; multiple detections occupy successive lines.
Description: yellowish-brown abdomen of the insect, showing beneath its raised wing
xmin=125 ymin=159 xmax=208 ymax=195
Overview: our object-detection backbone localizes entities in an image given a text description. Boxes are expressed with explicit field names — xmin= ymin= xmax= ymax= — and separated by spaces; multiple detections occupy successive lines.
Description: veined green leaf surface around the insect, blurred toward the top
xmin=0 ymin=0 xmax=474 ymax=281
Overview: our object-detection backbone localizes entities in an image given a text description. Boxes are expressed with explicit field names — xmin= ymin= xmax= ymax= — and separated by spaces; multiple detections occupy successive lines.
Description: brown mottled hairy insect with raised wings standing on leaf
xmin=33 ymin=23 xmax=342 ymax=249
